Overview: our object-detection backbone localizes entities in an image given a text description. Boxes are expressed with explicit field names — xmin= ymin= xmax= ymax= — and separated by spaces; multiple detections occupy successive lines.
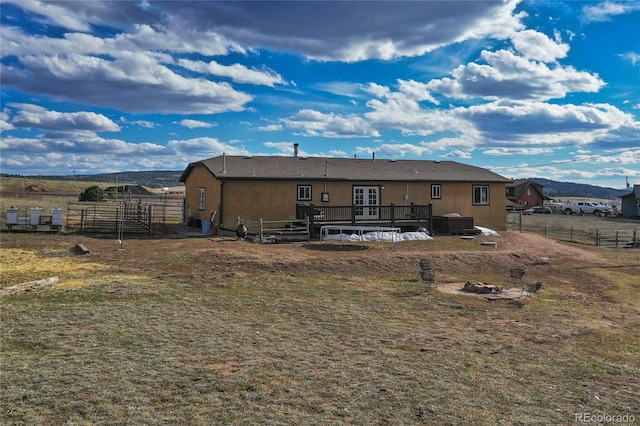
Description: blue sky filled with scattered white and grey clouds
xmin=0 ymin=0 xmax=640 ymax=188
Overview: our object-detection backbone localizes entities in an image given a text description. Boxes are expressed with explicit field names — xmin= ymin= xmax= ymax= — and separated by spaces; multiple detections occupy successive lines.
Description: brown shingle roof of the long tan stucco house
xmin=180 ymin=155 xmax=511 ymax=183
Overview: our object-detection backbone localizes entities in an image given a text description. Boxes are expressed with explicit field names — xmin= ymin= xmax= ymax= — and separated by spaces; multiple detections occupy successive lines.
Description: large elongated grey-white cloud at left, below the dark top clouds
xmin=2 ymin=53 xmax=253 ymax=114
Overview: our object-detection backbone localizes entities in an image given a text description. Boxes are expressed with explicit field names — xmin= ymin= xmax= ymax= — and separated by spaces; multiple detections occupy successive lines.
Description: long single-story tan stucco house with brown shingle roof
xmin=180 ymin=150 xmax=510 ymax=230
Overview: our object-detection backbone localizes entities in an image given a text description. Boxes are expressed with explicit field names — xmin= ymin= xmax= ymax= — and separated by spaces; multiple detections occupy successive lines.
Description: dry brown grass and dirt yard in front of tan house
xmin=0 ymin=225 xmax=640 ymax=425
